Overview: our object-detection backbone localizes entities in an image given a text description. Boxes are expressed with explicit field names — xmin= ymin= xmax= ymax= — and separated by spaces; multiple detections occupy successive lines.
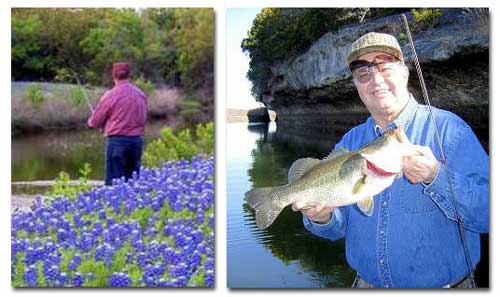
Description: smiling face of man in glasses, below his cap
xmin=354 ymin=52 xmax=408 ymax=117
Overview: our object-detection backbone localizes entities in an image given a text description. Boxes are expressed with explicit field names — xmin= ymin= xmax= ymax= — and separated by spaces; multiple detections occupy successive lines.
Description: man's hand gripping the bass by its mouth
xmin=403 ymin=145 xmax=439 ymax=184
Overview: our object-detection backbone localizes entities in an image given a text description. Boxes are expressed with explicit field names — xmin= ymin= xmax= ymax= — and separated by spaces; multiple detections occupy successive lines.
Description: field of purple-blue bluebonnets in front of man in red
xmin=11 ymin=125 xmax=215 ymax=287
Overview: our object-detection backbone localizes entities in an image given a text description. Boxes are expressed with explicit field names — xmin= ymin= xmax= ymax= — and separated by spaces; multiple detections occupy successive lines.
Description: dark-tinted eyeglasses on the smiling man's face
xmin=349 ymin=55 xmax=402 ymax=84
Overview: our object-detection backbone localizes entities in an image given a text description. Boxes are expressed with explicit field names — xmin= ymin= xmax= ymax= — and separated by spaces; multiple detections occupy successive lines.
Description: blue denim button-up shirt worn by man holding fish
xmin=304 ymin=98 xmax=489 ymax=288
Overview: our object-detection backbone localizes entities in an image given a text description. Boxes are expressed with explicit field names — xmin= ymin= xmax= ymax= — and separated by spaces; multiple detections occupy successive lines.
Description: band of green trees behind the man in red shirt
xmin=12 ymin=8 xmax=214 ymax=89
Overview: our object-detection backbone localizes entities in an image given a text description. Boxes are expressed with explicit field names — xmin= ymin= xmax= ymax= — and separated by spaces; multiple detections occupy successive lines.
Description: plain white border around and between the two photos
xmin=0 ymin=0 xmax=500 ymax=296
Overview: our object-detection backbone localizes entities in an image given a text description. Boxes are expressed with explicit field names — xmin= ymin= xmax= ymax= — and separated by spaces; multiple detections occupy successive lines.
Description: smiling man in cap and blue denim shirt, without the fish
xmin=292 ymin=32 xmax=489 ymax=288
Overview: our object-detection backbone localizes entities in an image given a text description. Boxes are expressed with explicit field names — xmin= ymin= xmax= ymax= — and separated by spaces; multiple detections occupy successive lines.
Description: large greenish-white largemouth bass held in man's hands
xmin=245 ymin=128 xmax=419 ymax=229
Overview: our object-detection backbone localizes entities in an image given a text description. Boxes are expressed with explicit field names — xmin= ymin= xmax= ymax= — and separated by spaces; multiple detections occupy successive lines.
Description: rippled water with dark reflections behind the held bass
xmin=227 ymin=123 xmax=354 ymax=288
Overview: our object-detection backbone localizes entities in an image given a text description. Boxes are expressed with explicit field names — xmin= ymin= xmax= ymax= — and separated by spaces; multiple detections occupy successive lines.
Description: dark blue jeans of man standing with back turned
xmin=104 ymin=135 xmax=144 ymax=185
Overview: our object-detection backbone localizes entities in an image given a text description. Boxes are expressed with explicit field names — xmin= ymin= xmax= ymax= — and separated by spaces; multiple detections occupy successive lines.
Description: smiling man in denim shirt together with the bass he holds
xmin=245 ymin=32 xmax=489 ymax=288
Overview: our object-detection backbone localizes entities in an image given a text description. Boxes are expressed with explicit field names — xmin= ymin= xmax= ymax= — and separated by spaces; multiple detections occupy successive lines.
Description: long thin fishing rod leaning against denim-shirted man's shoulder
xmin=400 ymin=14 xmax=476 ymax=288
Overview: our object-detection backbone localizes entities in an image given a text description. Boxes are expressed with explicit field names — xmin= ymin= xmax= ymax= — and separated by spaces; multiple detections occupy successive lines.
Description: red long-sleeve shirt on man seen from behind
xmin=88 ymin=80 xmax=147 ymax=136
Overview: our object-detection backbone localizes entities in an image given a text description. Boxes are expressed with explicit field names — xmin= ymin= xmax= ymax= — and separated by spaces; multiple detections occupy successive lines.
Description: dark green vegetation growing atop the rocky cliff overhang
xmin=241 ymin=8 xmax=408 ymax=98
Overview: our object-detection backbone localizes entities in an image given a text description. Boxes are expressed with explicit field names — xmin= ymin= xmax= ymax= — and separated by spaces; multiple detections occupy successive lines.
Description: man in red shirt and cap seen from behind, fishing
xmin=88 ymin=62 xmax=147 ymax=185
